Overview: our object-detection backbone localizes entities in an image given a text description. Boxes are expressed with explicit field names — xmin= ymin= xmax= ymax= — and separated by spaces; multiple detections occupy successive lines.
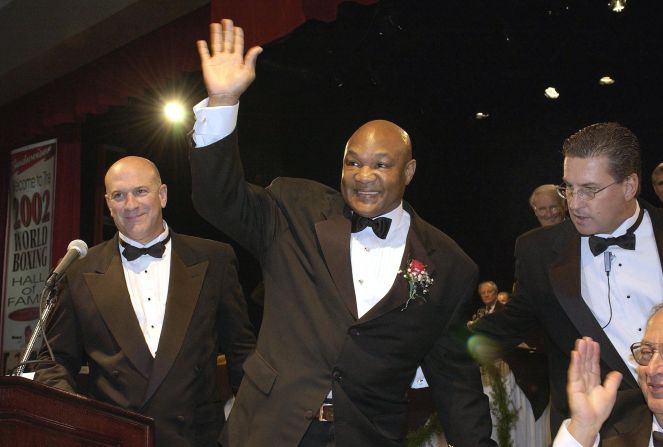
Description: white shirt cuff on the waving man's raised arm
xmin=193 ymin=98 xmax=239 ymax=147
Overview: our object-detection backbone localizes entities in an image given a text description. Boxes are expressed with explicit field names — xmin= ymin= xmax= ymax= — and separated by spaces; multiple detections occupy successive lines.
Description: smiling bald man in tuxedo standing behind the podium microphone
xmin=35 ymin=157 xmax=255 ymax=447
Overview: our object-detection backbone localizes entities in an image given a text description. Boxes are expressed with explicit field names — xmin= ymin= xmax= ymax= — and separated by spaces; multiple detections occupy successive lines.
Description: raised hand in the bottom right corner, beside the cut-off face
xmin=566 ymin=337 xmax=622 ymax=446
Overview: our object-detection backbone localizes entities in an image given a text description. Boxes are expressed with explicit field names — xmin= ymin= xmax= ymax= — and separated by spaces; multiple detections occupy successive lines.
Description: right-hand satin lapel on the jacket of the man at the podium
xmin=144 ymin=238 xmax=209 ymax=402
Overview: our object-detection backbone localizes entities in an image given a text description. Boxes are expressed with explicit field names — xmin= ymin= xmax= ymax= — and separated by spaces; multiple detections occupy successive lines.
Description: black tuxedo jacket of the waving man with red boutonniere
xmin=191 ymin=134 xmax=494 ymax=447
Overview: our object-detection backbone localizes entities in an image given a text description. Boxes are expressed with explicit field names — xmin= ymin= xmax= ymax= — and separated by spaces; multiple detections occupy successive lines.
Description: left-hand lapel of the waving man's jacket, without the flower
xmin=315 ymin=214 xmax=357 ymax=320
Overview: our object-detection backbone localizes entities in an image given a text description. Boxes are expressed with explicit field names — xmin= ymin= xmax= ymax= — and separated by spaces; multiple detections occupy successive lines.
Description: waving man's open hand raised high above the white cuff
xmin=196 ymin=19 xmax=262 ymax=107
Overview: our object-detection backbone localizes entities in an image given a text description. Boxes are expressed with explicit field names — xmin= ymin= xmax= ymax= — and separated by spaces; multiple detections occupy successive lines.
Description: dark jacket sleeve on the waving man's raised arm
xmin=190 ymin=131 xmax=283 ymax=258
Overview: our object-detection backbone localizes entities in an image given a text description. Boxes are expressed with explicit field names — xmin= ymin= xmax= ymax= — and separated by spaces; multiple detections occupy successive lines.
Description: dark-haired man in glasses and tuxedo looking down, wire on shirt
xmin=475 ymin=123 xmax=663 ymax=434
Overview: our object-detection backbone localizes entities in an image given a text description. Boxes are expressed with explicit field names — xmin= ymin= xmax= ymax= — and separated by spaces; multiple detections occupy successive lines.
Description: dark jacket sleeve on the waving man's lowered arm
xmin=422 ymin=267 xmax=495 ymax=446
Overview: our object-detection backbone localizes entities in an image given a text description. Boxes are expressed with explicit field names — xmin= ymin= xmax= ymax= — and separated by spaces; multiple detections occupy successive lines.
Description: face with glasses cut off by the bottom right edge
xmin=638 ymin=310 xmax=663 ymax=421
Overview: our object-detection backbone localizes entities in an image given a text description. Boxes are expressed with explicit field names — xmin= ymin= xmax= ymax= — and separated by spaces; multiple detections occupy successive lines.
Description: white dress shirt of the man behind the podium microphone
xmin=119 ymin=222 xmax=172 ymax=357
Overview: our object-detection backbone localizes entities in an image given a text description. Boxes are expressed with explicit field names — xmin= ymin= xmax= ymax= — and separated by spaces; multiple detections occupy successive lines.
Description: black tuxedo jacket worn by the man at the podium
xmin=35 ymin=230 xmax=255 ymax=447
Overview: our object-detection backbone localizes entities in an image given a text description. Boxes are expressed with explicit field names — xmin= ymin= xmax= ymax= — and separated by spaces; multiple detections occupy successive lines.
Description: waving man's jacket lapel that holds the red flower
xmin=359 ymin=216 xmax=435 ymax=323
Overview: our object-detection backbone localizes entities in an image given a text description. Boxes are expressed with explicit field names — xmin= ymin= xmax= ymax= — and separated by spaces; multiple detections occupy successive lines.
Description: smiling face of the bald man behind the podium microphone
xmin=105 ymin=157 xmax=168 ymax=244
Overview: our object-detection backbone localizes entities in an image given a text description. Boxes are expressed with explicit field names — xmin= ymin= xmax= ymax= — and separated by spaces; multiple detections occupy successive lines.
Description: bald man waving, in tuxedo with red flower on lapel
xmin=191 ymin=20 xmax=495 ymax=447
